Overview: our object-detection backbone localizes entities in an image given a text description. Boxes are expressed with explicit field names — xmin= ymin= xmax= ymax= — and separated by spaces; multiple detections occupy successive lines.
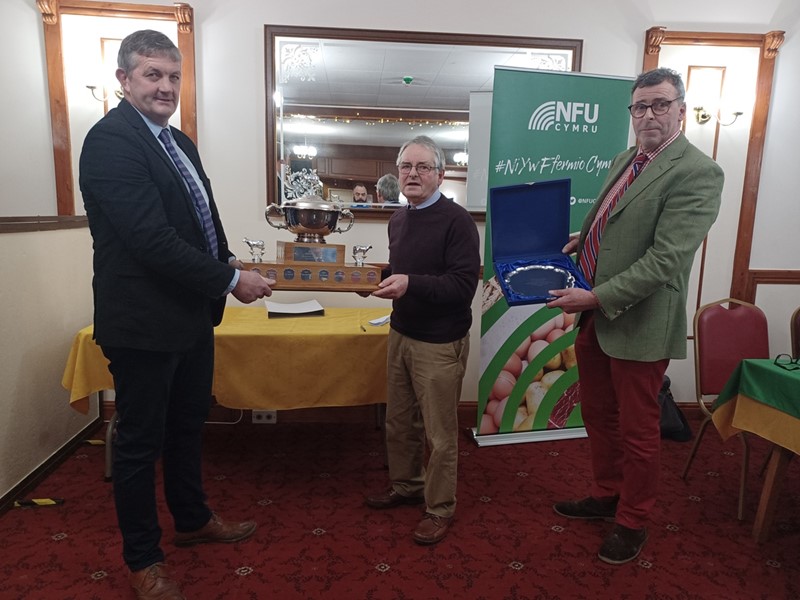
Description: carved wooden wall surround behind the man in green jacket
xmin=642 ymin=27 xmax=788 ymax=302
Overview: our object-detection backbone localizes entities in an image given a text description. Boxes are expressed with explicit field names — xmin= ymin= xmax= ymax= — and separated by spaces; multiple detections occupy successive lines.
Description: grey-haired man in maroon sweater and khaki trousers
xmin=366 ymin=136 xmax=481 ymax=544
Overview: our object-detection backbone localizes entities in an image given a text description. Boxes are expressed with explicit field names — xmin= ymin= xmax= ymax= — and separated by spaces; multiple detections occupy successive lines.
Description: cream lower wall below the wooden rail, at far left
xmin=0 ymin=229 xmax=99 ymax=495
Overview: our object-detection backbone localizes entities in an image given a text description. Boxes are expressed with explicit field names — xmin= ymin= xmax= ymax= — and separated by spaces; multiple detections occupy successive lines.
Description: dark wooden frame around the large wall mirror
xmin=264 ymin=25 xmax=583 ymax=221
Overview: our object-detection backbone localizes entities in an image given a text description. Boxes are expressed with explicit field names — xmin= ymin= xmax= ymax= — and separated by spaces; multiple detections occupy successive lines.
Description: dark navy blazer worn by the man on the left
xmin=80 ymin=100 xmax=234 ymax=352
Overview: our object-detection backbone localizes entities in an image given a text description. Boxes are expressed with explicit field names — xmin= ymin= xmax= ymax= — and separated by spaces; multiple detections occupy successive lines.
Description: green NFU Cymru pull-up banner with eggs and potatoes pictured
xmin=475 ymin=67 xmax=632 ymax=445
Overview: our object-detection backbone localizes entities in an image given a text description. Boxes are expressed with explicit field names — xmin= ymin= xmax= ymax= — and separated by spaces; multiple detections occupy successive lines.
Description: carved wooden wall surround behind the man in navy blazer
xmin=36 ymin=0 xmax=197 ymax=216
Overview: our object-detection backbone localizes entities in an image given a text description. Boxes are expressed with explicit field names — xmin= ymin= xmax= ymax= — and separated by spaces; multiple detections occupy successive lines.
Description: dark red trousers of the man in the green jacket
xmin=575 ymin=313 xmax=669 ymax=529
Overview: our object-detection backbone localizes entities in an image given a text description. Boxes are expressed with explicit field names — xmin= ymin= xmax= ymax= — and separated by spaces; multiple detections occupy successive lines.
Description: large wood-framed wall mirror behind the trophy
xmin=265 ymin=25 xmax=583 ymax=220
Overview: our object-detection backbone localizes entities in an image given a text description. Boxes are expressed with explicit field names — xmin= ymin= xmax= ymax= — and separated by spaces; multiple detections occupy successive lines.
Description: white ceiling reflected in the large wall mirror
xmin=275 ymin=37 xmax=572 ymax=149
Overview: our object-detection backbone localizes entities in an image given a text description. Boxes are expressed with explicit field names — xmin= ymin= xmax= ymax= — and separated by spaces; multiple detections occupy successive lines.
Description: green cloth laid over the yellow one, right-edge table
xmin=713 ymin=358 xmax=800 ymax=419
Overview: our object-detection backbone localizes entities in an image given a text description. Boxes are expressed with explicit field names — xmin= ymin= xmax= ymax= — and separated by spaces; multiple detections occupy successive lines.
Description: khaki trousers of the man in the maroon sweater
xmin=386 ymin=330 xmax=469 ymax=517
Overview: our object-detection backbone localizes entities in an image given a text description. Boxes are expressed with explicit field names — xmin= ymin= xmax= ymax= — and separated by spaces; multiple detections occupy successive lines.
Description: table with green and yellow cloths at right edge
xmin=711 ymin=359 xmax=800 ymax=542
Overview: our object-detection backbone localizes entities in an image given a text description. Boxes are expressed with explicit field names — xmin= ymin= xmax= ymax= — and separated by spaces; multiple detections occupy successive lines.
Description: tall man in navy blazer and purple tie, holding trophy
xmin=80 ymin=30 xmax=275 ymax=599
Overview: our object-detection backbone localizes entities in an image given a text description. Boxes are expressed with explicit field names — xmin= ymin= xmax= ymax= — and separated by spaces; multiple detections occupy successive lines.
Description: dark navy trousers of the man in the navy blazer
xmin=102 ymin=333 xmax=214 ymax=571
